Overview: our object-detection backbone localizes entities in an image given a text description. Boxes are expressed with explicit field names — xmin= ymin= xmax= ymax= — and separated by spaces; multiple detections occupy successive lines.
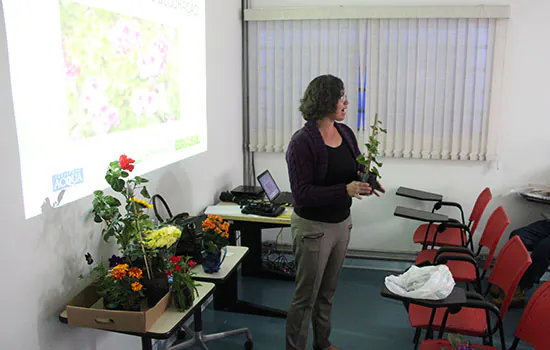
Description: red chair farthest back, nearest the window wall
xmin=413 ymin=187 xmax=493 ymax=250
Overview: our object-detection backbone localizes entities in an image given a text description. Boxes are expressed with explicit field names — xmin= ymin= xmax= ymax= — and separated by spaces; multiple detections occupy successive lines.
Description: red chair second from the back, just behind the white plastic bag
xmin=416 ymin=206 xmax=510 ymax=293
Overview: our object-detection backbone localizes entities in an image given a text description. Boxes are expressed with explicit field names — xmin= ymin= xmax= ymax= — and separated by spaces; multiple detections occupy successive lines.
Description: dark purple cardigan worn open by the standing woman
xmin=286 ymin=120 xmax=363 ymax=206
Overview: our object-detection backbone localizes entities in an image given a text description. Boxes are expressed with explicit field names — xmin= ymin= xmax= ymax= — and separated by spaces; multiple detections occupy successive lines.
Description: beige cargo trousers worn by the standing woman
xmin=286 ymin=213 xmax=352 ymax=350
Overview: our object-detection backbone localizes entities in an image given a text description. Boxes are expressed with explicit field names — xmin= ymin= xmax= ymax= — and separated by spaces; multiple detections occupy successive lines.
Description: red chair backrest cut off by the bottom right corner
xmin=514 ymin=281 xmax=550 ymax=349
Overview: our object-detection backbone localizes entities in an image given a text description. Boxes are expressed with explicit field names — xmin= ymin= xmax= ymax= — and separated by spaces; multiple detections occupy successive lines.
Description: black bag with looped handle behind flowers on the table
xmin=151 ymin=194 xmax=206 ymax=264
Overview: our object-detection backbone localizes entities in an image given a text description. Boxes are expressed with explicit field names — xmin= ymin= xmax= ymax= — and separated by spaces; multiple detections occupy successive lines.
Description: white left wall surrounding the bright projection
xmin=0 ymin=0 xmax=242 ymax=350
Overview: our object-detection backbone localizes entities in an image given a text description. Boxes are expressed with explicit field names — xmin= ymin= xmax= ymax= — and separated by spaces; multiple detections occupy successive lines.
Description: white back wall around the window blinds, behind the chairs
xmin=251 ymin=0 xmax=550 ymax=251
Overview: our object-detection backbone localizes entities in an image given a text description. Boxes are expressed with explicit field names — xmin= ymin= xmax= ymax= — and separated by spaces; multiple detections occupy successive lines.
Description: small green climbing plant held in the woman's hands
xmin=357 ymin=113 xmax=388 ymax=190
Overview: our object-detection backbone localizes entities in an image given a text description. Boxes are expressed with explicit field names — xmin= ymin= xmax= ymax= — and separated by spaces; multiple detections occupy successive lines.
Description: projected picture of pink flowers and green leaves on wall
xmin=60 ymin=0 xmax=180 ymax=138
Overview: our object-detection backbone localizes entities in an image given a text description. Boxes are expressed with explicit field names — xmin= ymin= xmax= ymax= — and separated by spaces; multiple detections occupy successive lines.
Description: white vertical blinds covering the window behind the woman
xmin=248 ymin=9 xmax=503 ymax=160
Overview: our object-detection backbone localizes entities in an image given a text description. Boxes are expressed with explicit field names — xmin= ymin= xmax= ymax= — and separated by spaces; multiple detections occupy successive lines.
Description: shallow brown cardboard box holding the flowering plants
xmin=67 ymin=286 xmax=172 ymax=333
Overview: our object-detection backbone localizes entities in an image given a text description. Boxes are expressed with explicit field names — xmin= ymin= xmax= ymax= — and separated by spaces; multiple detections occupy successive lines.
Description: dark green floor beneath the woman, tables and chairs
xmin=178 ymin=268 xmax=532 ymax=350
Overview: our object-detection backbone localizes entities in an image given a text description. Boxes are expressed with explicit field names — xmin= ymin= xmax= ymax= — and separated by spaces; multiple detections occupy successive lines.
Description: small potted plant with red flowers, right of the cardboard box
xmin=166 ymin=256 xmax=203 ymax=311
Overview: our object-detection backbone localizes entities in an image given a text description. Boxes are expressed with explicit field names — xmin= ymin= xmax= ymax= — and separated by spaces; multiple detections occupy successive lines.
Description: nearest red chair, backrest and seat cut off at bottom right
xmin=420 ymin=281 xmax=550 ymax=350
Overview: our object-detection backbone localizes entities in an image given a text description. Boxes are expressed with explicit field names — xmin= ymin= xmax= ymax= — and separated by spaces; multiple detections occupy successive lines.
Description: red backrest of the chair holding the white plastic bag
xmin=489 ymin=236 xmax=531 ymax=319
